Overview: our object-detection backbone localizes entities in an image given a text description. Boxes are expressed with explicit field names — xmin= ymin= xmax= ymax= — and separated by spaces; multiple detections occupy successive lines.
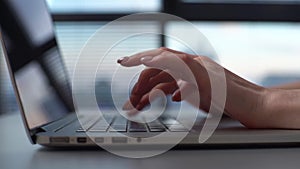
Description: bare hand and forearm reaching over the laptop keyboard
xmin=118 ymin=47 xmax=300 ymax=129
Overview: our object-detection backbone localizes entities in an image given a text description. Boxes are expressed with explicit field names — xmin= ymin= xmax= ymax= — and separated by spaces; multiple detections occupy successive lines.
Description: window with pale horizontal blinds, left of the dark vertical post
xmin=0 ymin=22 xmax=160 ymax=112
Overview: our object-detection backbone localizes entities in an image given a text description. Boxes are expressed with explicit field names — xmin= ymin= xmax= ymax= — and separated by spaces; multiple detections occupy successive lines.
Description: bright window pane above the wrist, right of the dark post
xmin=166 ymin=21 xmax=300 ymax=86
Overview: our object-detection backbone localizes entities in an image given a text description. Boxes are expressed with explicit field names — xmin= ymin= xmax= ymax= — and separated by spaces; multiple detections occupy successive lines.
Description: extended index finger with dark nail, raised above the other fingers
xmin=118 ymin=49 xmax=163 ymax=67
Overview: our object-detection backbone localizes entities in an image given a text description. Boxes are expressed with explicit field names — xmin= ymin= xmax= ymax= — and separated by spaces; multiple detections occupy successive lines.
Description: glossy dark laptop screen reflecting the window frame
xmin=0 ymin=0 xmax=73 ymax=129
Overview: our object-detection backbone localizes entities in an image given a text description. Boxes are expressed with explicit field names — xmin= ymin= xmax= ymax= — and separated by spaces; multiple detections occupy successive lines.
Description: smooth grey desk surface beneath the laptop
xmin=0 ymin=114 xmax=300 ymax=169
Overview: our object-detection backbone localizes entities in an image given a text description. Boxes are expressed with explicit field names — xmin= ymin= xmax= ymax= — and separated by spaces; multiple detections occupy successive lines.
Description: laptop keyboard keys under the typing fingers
xmin=76 ymin=116 xmax=188 ymax=132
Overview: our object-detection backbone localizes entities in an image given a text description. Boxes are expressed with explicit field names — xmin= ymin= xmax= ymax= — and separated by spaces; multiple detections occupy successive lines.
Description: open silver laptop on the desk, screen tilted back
xmin=0 ymin=0 xmax=300 ymax=147
